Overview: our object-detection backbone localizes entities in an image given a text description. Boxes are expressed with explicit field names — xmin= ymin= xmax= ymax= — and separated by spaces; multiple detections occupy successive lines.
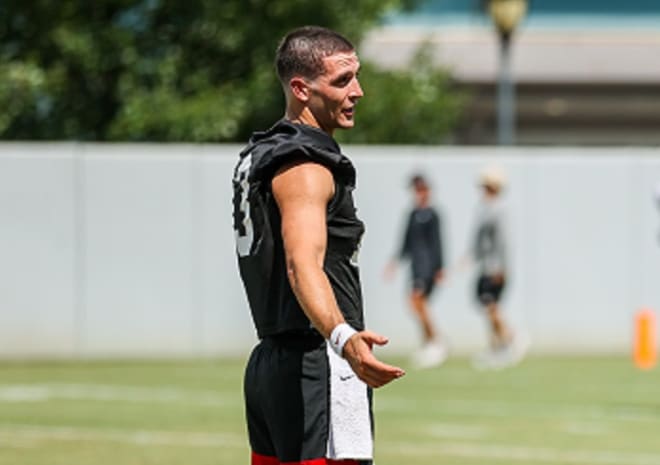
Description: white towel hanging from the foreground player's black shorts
xmin=327 ymin=344 xmax=373 ymax=460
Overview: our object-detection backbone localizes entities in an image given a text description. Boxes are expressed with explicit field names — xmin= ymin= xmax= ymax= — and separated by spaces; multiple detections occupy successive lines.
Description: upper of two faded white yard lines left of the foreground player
xmin=0 ymin=384 xmax=231 ymax=407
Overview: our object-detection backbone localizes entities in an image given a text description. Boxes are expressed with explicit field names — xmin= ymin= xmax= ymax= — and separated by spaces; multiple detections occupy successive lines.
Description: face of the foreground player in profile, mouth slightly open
xmin=307 ymin=52 xmax=364 ymax=134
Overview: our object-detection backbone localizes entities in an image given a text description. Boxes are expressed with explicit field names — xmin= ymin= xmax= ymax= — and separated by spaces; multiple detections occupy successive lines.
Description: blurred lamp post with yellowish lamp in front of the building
xmin=488 ymin=0 xmax=527 ymax=145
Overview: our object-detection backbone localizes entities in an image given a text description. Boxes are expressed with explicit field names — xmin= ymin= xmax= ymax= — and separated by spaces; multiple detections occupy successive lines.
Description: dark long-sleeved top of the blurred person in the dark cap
xmin=400 ymin=207 xmax=443 ymax=278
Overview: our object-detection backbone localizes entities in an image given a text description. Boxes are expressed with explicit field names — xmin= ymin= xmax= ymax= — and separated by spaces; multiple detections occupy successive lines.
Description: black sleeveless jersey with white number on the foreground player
xmin=233 ymin=120 xmax=364 ymax=338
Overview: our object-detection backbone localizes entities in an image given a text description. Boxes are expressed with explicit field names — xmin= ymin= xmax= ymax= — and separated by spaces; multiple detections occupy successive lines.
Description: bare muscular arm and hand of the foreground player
xmin=272 ymin=162 xmax=404 ymax=387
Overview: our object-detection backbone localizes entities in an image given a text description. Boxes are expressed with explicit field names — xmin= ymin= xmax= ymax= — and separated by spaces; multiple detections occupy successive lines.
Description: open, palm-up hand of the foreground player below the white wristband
xmin=343 ymin=331 xmax=406 ymax=388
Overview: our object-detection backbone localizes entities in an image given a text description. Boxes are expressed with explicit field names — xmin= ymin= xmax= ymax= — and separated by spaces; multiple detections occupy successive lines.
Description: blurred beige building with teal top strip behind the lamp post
xmin=362 ymin=0 xmax=660 ymax=145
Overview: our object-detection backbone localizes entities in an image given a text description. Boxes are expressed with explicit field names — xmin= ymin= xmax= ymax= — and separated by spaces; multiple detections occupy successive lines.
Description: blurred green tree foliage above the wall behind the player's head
xmin=0 ymin=0 xmax=464 ymax=142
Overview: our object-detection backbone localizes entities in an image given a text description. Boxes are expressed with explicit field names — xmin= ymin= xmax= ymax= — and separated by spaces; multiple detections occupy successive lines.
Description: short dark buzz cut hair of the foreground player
xmin=275 ymin=26 xmax=355 ymax=87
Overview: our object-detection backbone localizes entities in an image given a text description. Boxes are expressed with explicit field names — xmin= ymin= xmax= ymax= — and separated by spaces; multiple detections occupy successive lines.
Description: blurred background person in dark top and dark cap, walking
xmin=385 ymin=174 xmax=447 ymax=368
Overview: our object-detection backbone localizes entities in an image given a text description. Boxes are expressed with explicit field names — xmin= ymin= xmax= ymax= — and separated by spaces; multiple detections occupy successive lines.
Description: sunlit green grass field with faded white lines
xmin=0 ymin=357 xmax=660 ymax=465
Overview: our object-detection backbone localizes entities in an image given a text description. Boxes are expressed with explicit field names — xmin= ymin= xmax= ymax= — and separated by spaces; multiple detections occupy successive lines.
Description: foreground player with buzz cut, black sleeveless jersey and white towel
xmin=233 ymin=26 xmax=404 ymax=465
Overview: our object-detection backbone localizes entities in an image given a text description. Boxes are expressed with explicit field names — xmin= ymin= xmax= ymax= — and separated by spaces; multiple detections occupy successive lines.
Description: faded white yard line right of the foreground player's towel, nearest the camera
xmin=378 ymin=443 xmax=660 ymax=465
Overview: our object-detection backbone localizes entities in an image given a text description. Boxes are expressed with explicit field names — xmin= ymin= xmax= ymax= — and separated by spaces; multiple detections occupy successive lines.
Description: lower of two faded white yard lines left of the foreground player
xmin=0 ymin=424 xmax=247 ymax=447
